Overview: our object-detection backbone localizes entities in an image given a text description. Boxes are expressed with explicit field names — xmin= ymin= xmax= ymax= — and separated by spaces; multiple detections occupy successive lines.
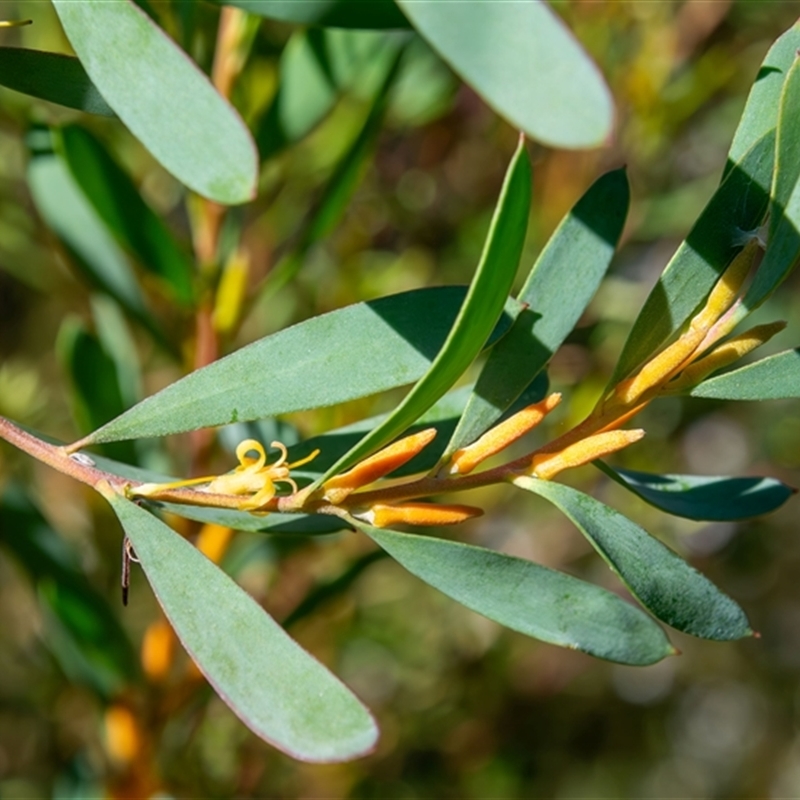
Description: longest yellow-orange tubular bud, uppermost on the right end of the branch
xmin=612 ymin=239 xmax=759 ymax=406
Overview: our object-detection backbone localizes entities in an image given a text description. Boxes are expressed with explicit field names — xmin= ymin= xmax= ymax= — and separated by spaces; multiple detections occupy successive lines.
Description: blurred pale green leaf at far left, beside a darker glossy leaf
xmin=28 ymin=129 xmax=166 ymax=342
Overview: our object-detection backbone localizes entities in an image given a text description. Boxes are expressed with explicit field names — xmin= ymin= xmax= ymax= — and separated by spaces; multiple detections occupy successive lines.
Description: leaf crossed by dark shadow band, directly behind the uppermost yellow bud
xmin=611 ymin=132 xmax=775 ymax=384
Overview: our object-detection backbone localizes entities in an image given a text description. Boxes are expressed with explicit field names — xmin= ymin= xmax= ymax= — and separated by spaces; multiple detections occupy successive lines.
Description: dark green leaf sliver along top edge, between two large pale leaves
xmin=206 ymin=0 xmax=408 ymax=29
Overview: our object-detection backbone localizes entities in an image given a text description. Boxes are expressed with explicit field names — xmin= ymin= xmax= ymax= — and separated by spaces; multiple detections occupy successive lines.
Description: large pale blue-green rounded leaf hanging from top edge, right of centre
xmin=397 ymin=0 xmax=614 ymax=148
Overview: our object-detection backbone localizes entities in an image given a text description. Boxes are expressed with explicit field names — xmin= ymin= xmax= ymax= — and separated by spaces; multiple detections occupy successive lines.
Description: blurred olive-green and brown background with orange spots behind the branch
xmin=0 ymin=0 xmax=800 ymax=800
